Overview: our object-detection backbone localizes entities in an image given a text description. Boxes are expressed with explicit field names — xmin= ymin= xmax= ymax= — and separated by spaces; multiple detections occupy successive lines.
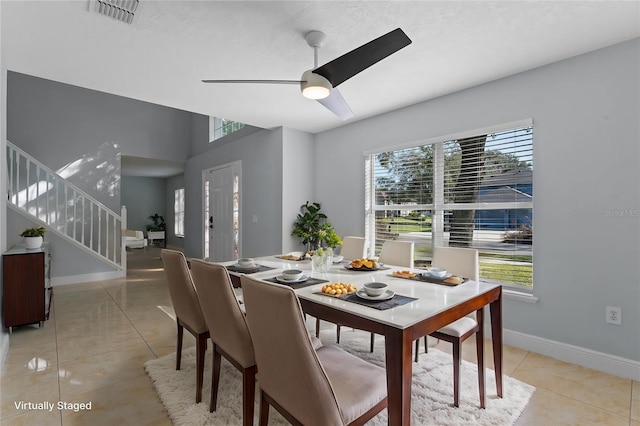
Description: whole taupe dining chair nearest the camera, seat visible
xmin=241 ymin=276 xmax=387 ymax=426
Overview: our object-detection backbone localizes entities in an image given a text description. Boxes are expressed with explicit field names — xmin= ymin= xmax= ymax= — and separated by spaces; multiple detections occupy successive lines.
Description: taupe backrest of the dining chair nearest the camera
xmin=241 ymin=275 xmax=344 ymax=425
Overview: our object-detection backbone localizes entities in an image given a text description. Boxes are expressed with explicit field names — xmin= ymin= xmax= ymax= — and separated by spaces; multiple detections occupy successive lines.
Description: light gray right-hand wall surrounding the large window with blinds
xmin=315 ymin=39 xmax=640 ymax=361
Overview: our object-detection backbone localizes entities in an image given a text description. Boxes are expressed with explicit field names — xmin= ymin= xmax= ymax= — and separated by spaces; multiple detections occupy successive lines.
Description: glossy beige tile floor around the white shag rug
xmin=0 ymin=247 xmax=640 ymax=426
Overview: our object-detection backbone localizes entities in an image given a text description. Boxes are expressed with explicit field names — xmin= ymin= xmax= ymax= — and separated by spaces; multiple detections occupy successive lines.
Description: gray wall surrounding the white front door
xmin=184 ymin=123 xmax=282 ymax=257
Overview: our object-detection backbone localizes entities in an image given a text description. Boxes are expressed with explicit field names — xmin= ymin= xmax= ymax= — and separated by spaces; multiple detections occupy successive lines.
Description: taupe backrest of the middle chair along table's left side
xmin=191 ymin=259 xmax=256 ymax=368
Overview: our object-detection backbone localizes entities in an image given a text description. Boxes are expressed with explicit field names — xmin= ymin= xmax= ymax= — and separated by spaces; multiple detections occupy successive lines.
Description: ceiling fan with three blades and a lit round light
xmin=202 ymin=28 xmax=411 ymax=120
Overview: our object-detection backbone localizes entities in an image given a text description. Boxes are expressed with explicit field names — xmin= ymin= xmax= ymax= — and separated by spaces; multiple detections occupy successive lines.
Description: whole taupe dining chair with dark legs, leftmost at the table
xmin=160 ymin=249 xmax=209 ymax=403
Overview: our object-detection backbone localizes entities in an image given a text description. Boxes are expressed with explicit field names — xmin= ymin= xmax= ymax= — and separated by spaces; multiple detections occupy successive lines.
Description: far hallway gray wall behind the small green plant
xmin=122 ymin=176 xmax=168 ymax=237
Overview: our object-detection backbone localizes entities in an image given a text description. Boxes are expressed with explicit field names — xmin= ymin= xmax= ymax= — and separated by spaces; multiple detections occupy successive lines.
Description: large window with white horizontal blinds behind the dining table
xmin=365 ymin=121 xmax=533 ymax=289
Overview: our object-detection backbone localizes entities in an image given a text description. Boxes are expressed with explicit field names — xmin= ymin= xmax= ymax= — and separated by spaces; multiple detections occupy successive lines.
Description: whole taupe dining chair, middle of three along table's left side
xmin=191 ymin=259 xmax=256 ymax=425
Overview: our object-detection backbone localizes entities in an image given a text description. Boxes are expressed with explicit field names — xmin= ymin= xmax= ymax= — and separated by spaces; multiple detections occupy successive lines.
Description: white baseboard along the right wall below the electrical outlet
xmin=503 ymin=330 xmax=640 ymax=381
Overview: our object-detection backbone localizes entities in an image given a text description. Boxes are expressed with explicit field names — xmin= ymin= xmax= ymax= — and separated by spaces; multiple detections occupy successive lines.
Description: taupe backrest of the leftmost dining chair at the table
xmin=160 ymin=249 xmax=207 ymax=334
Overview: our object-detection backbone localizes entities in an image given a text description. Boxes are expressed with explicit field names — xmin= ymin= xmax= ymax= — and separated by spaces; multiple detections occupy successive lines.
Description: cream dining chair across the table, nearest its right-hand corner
xmin=415 ymin=247 xmax=484 ymax=408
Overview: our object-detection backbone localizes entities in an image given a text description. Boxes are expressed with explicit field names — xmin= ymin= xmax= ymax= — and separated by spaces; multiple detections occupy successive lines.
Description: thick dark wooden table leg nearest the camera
xmin=385 ymin=329 xmax=413 ymax=426
